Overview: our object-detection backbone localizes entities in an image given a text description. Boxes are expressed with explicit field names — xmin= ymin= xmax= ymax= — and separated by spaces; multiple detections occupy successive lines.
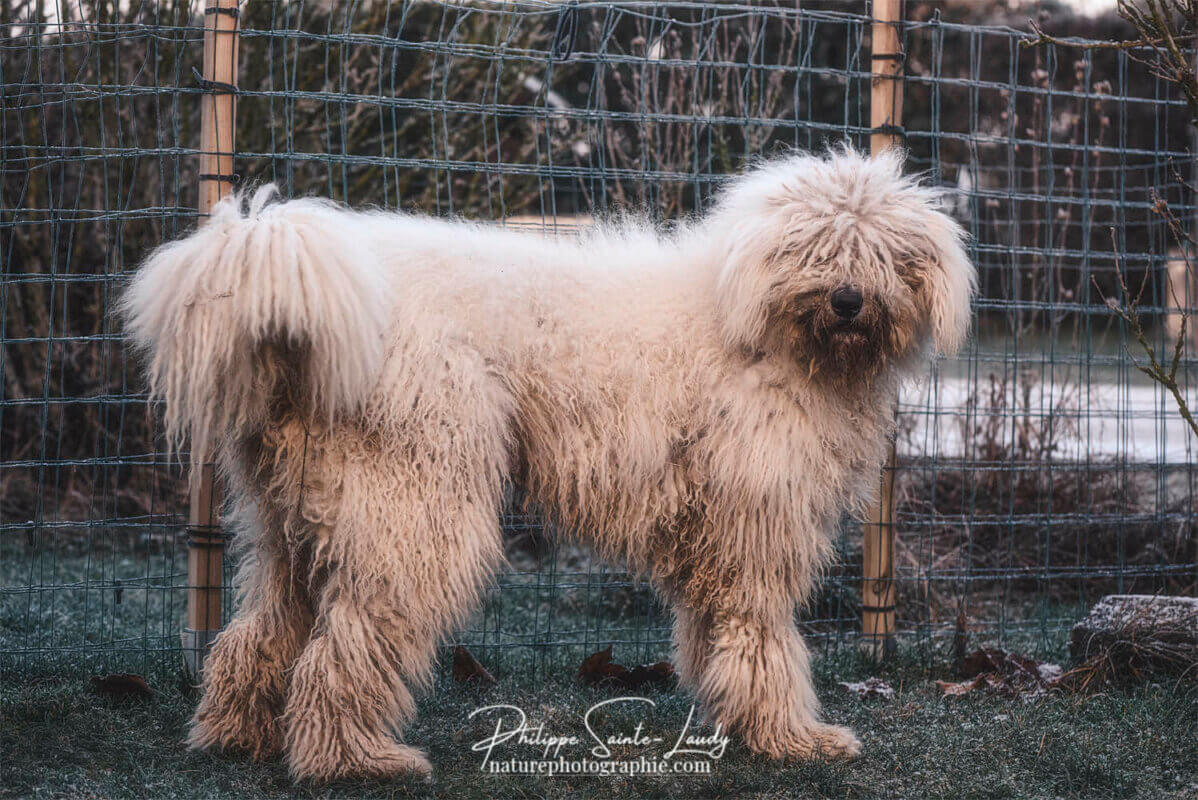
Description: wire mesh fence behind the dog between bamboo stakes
xmin=0 ymin=0 xmax=1198 ymax=673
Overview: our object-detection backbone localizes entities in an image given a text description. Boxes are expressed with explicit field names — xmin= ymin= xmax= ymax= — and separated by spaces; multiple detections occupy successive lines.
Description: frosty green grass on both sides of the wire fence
xmin=9 ymin=545 xmax=1198 ymax=800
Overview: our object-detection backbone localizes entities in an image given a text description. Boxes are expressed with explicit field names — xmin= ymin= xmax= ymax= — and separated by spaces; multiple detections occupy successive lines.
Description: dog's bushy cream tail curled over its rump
xmin=120 ymin=186 xmax=391 ymax=465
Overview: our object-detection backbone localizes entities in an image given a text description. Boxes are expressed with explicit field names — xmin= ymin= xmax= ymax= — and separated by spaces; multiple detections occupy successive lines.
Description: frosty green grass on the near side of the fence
xmin=0 ymin=651 xmax=1198 ymax=800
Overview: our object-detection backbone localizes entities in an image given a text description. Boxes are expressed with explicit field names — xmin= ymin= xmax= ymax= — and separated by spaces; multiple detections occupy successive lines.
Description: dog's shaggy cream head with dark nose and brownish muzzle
xmin=715 ymin=149 xmax=976 ymax=383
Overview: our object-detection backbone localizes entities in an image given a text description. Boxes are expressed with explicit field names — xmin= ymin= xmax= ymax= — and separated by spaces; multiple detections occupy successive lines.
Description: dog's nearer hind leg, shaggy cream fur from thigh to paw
xmin=285 ymin=397 xmax=506 ymax=781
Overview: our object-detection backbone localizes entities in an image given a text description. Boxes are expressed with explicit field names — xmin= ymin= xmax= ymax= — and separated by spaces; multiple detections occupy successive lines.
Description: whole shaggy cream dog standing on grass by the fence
xmin=123 ymin=149 xmax=975 ymax=780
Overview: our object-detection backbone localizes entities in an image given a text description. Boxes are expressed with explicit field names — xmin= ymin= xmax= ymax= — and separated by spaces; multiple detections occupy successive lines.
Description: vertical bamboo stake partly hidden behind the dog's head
xmin=861 ymin=0 xmax=903 ymax=661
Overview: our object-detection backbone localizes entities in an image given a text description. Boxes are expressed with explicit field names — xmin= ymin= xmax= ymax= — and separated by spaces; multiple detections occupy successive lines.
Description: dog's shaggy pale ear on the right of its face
xmin=910 ymin=211 xmax=978 ymax=356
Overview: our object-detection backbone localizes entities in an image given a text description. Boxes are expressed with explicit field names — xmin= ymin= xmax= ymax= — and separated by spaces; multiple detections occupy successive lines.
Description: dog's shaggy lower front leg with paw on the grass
xmin=697 ymin=608 xmax=861 ymax=758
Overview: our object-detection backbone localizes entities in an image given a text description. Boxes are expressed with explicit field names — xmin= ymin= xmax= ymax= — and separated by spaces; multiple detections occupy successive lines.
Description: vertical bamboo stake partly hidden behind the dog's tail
xmin=182 ymin=0 xmax=240 ymax=678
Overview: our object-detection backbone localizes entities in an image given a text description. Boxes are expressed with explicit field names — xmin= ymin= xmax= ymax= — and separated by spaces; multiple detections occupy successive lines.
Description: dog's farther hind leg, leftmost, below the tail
xmin=188 ymin=505 xmax=311 ymax=759
